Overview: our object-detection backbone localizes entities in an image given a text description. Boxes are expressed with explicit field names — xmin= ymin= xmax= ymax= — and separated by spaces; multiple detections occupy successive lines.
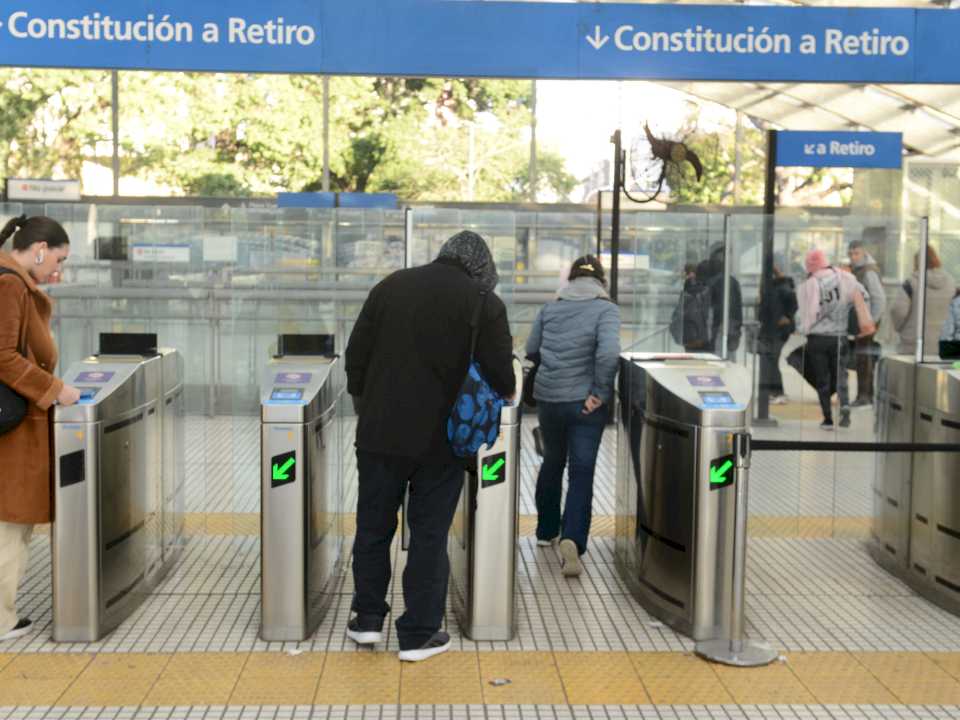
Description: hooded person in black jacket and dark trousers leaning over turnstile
xmin=346 ymin=231 xmax=516 ymax=661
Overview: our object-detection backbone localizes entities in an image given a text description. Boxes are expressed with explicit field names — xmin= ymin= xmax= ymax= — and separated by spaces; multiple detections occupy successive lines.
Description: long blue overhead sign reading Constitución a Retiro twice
xmin=0 ymin=0 xmax=960 ymax=83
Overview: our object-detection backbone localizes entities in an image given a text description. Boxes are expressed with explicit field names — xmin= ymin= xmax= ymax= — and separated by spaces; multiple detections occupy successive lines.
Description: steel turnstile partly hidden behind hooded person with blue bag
xmin=448 ymin=359 xmax=523 ymax=641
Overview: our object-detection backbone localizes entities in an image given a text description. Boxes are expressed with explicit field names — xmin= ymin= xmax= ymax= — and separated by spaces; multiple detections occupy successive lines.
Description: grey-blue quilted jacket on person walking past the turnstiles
xmin=527 ymin=277 xmax=620 ymax=404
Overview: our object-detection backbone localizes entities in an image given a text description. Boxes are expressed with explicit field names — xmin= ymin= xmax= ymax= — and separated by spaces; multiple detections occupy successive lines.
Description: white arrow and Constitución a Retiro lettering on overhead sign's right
xmin=612 ymin=25 xmax=910 ymax=57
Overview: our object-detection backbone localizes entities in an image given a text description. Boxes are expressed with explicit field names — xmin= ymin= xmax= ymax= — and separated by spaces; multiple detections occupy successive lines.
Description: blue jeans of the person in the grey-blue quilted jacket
xmin=537 ymin=401 xmax=608 ymax=555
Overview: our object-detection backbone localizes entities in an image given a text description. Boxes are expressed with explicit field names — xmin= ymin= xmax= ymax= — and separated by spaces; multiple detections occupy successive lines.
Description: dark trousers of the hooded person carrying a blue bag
xmin=353 ymin=451 xmax=464 ymax=650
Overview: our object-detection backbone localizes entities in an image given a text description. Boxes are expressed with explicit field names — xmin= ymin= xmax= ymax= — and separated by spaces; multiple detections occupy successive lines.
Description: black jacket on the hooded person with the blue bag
xmin=346 ymin=258 xmax=516 ymax=464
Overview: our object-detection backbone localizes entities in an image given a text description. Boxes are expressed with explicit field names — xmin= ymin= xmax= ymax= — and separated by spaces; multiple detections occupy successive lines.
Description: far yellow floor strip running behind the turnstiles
xmin=174 ymin=513 xmax=873 ymax=538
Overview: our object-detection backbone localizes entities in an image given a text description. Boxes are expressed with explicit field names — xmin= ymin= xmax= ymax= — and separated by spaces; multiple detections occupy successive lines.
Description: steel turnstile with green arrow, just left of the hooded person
xmin=260 ymin=357 xmax=345 ymax=641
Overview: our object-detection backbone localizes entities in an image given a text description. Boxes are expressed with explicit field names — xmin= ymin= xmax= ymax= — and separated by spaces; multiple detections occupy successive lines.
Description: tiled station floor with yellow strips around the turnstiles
xmin=0 ymin=408 xmax=960 ymax=720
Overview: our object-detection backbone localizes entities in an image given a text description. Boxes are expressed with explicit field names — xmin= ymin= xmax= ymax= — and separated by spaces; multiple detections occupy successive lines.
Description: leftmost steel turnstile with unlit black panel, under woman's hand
xmin=52 ymin=350 xmax=184 ymax=642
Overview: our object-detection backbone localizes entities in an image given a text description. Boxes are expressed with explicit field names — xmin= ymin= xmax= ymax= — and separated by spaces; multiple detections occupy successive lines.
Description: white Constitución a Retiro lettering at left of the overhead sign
xmin=0 ymin=10 xmax=317 ymax=47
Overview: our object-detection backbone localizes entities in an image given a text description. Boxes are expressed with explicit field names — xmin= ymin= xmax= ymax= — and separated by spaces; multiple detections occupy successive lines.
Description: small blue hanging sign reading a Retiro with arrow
xmin=777 ymin=131 xmax=903 ymax=170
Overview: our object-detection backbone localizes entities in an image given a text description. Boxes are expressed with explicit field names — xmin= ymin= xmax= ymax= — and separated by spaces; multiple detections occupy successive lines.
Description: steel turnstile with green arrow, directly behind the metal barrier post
xmin=615 ymin=353 xmax=751 ymax=640
